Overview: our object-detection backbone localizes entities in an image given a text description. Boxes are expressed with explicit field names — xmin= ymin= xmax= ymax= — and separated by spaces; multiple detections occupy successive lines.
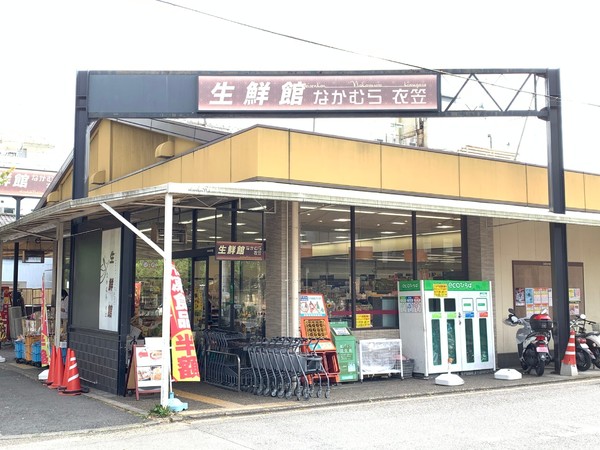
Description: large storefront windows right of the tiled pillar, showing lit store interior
xmin=300 ymin=203 xmax=464 ymax=328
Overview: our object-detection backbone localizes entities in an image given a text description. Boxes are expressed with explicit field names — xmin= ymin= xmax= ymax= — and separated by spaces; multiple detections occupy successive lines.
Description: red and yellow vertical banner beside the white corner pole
xmin=171 ymin=264 xmax=200 ymax=381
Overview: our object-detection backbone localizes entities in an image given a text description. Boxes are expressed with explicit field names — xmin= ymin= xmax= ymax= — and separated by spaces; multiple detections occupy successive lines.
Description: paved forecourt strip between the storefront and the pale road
xmin=0 ymin=344 xmax=600 ymax=446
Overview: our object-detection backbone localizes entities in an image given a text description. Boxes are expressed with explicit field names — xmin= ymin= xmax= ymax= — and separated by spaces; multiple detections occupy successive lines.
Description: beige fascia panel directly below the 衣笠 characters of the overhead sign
xmin=381 ymin=145 xmax=460 ymax=197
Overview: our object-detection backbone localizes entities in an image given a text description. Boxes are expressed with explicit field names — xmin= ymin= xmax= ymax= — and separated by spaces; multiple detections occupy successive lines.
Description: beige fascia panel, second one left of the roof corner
xmin=193 ymin=139 xmax=231 ymax=183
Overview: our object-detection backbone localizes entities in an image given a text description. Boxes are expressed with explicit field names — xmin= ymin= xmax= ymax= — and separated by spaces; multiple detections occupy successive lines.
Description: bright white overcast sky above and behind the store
xmin=0 ymin=0 xmax=600 ymax=173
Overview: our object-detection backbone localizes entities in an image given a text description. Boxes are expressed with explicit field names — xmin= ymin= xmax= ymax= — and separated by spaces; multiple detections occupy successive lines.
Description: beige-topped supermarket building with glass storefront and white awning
xmin=0 ymin=119 xmax=600 ymax=393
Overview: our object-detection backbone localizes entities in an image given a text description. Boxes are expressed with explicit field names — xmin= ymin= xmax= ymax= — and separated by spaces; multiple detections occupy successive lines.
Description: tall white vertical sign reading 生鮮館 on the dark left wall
xmin=98 ymin=228 xmax=121 ymax=331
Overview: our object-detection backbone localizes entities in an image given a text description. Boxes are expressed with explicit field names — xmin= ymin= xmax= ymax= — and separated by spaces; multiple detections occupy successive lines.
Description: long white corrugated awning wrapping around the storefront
xmin=0 ymin=181 xmax=600 ymax=242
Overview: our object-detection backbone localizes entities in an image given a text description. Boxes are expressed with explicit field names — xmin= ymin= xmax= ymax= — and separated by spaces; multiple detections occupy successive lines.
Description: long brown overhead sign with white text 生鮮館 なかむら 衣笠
xmin=198 ymin=74 xmax=440 ymax=112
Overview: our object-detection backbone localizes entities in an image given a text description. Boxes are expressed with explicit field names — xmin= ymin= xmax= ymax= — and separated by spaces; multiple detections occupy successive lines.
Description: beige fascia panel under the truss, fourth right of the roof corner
xmin=459 ymin=156 xmax=527 ymax=204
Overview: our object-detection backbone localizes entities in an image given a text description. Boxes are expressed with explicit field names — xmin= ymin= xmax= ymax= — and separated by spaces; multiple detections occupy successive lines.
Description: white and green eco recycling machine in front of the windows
xmin=398 ymin=280 xmax=496 ymax=376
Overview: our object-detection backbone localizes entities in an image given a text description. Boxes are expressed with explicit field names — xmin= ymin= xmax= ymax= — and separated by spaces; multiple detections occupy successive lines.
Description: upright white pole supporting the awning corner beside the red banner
xmin=160 ymin=194 xmax=173 ymax=407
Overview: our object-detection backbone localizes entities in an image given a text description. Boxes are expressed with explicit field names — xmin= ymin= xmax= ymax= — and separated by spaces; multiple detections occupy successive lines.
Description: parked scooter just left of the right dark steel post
xmin=504 ymin=308 xmax=553 ymax=377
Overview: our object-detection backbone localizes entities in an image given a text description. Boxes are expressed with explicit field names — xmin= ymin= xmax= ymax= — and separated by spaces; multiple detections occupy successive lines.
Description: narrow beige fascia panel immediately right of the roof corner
xmin=258 ymin=128 xmax=290 ymax=180
